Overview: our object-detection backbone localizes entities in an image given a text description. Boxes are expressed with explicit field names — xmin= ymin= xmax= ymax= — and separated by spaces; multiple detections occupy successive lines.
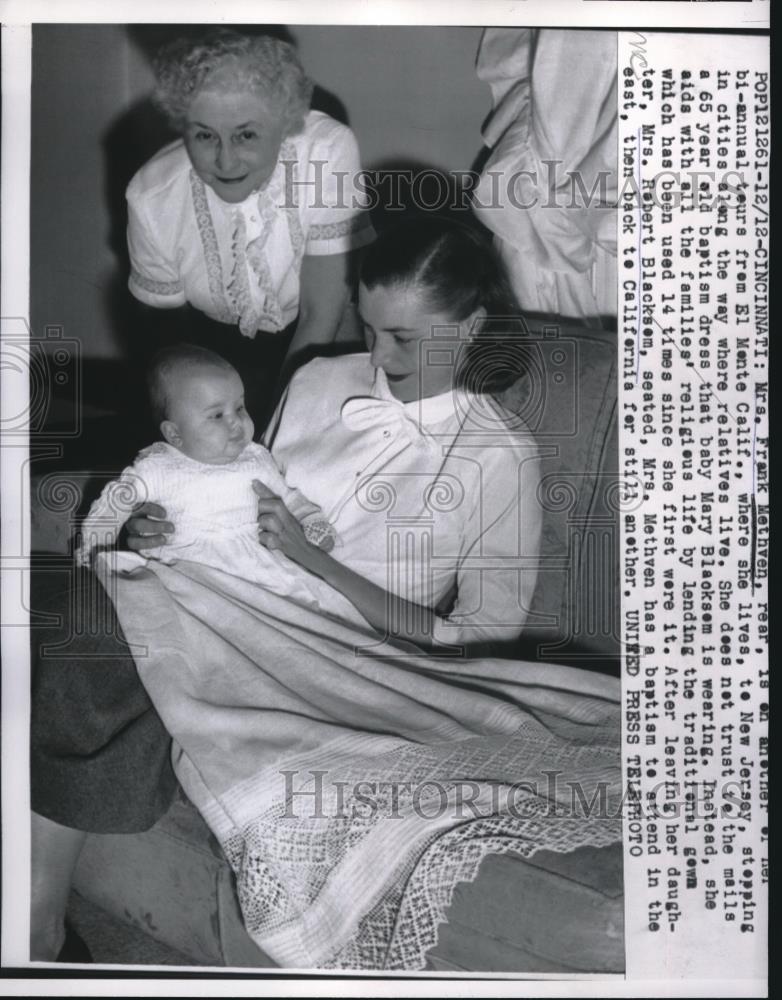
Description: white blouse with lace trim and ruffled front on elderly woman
xmin=127 ymin=111 xmax=374 ymax=337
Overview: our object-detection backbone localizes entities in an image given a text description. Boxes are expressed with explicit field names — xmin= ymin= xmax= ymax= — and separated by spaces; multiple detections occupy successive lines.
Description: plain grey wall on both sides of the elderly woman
xmin=30 ymin=25 xmax=490 ymax=358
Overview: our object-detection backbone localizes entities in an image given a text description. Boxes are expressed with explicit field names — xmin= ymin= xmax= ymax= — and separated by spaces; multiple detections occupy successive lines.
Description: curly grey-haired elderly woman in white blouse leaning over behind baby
xmin=127 ymin=29 xmax=373 ymax=410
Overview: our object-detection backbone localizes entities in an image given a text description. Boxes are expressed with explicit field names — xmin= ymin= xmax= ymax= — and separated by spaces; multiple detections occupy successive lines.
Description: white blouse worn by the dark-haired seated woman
xmin=267 ymin=354 xmax=541 ymax=646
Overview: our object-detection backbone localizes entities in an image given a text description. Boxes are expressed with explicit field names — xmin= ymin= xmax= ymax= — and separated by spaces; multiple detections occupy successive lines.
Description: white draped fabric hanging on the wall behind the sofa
xmin=473 ymin=28 xmax=618 ymax=324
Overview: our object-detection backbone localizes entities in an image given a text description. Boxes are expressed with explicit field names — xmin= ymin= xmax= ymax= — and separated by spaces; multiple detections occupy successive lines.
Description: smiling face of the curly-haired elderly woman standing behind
xmin=184 ymin=89 xmax=284 ymax=204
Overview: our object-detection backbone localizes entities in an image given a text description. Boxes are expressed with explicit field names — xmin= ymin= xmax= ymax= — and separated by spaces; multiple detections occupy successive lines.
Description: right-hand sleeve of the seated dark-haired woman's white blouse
xmin=434 ymin=438 xmax=542 ymax=652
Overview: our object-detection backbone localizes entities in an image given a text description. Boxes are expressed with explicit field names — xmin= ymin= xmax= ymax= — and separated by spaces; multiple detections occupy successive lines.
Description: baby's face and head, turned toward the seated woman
xmin=162 ymin=367 xmax=255 ymax=465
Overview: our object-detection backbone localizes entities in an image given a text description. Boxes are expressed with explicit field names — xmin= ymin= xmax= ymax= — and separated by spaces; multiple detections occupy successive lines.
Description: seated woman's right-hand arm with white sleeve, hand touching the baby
xmin=257 ymin=410 xmax=543 ymax=654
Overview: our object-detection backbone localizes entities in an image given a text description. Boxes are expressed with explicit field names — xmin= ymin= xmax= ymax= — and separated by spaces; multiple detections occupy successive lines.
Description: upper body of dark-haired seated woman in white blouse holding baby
xmin=130 ymin=219 xmax=541 ymax=646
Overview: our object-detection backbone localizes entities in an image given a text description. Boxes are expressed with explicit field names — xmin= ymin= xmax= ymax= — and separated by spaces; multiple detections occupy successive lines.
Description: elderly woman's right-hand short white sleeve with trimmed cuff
xmin=304 ymin=122 xmax=375 ymax=256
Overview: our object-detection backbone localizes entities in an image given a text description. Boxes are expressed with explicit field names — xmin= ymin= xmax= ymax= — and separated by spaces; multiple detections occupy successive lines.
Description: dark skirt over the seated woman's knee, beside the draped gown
xmin=30 ymin=570 xmax=177 ymax=833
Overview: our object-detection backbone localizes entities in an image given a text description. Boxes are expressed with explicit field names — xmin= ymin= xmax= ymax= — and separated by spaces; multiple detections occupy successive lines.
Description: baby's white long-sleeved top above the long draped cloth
xmin=77 ymin=441 xmax=334 ymax=607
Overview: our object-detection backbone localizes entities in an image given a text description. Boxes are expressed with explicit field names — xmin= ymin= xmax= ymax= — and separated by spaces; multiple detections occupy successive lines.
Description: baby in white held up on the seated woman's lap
xmin=76 ymin=344 xmax=335 ymax=602
